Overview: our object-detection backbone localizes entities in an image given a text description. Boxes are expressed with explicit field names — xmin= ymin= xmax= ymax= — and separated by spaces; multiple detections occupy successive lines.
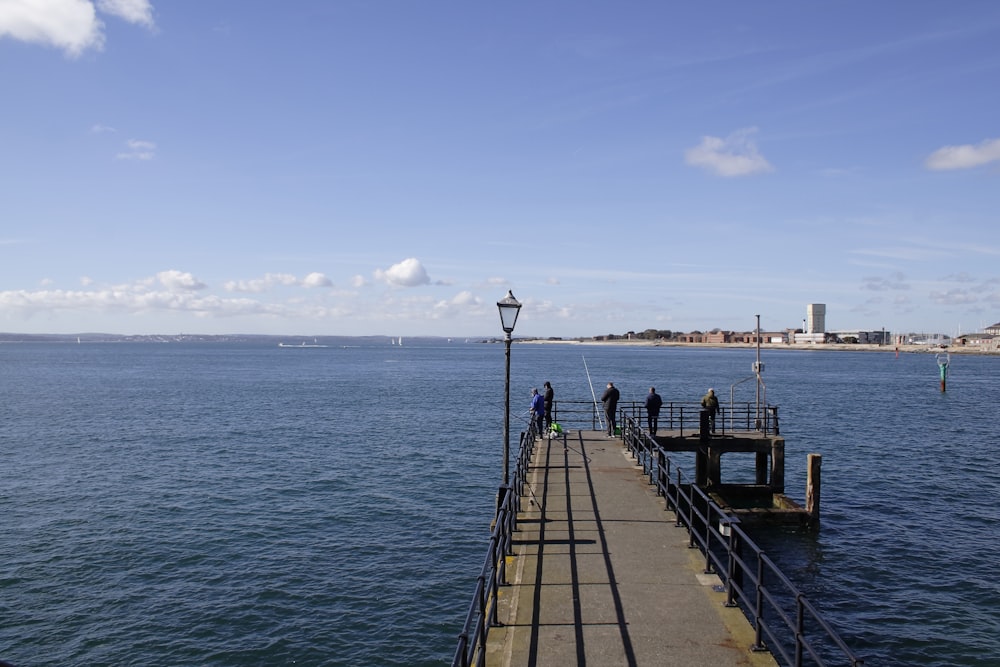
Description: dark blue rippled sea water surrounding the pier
xmin=0 ymin=339 xmax=1000 ymax=667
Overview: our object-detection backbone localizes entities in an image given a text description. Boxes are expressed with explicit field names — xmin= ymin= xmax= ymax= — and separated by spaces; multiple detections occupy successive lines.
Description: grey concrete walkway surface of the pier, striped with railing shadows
xmin=486 ymin=431 xmax=776 ymax=667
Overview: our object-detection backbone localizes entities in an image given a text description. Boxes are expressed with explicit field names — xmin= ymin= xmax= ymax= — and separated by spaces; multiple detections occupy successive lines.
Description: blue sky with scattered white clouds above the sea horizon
xmin=0 ymin=0 xmax=1000 ymax=337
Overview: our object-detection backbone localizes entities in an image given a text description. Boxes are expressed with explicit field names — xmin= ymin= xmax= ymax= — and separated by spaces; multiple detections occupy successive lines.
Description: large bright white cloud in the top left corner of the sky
xmin=0 ymin=0 xmax=153 ymax=58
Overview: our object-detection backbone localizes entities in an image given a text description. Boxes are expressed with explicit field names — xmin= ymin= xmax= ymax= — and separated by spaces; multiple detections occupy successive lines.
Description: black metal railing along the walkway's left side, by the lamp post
xmin=452 ymin=424 xmax=537 ymax=667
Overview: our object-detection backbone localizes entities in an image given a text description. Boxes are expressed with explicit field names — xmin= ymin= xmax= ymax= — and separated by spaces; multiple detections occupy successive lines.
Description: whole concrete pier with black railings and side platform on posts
xmin=453 ymin=404 xmax=863 ymax=667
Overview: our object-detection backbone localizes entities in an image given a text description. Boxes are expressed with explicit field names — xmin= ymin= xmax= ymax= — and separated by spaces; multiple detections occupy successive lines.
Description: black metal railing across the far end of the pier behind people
xmin=552 ymin=401 xmax=780 ymax=437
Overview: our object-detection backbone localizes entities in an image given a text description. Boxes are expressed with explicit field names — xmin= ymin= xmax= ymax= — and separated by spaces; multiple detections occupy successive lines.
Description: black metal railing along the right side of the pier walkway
xmin=622 ymin=417 xmax=864 ymax=667
